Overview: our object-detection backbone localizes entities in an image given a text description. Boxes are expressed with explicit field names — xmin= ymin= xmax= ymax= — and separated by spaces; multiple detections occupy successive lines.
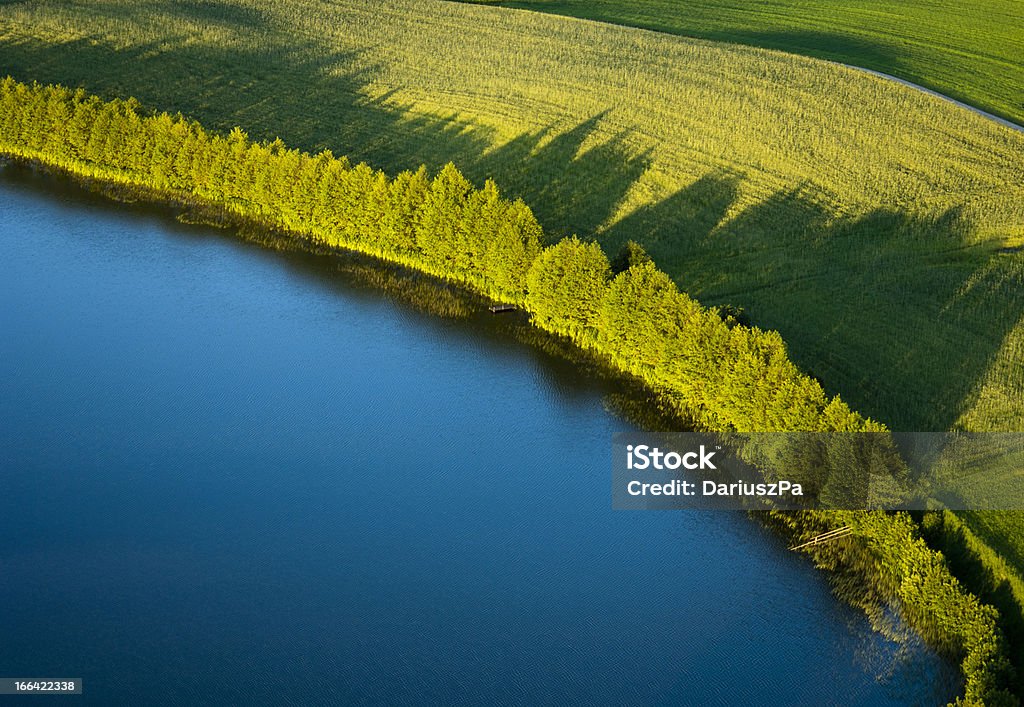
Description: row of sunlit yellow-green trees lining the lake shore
xmin=0 ymin=77 xmax=1007 ymax=699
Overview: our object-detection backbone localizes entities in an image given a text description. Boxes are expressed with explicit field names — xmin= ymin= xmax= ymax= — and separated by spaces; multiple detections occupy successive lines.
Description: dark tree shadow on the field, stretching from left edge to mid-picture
xmin=0 ymin=2 xmax=649 ymax=238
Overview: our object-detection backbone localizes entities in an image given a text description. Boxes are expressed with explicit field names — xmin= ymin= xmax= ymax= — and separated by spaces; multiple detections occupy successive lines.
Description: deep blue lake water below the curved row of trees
xmin=0 ymin=168 xmax=955 ymax=706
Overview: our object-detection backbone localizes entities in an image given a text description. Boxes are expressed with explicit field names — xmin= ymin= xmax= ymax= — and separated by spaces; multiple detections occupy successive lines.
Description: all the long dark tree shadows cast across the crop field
xmin=0 ymin=2 xmax=1024 ymax=429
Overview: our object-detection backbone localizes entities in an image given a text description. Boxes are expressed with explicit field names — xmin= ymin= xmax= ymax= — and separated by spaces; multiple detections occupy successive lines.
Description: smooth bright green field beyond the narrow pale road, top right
xmin=464 ymin=0 xmax=1024 ymax=125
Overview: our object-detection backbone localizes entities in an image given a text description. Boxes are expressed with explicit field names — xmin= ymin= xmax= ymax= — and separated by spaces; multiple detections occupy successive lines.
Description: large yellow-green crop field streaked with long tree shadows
xmin=6 ymin=0 xmax=1024 ymax=614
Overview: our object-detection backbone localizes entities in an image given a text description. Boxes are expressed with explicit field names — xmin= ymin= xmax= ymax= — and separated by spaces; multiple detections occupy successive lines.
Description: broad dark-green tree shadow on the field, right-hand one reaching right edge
xmin=602 ymin=173 xmax=1024 ymax=430
